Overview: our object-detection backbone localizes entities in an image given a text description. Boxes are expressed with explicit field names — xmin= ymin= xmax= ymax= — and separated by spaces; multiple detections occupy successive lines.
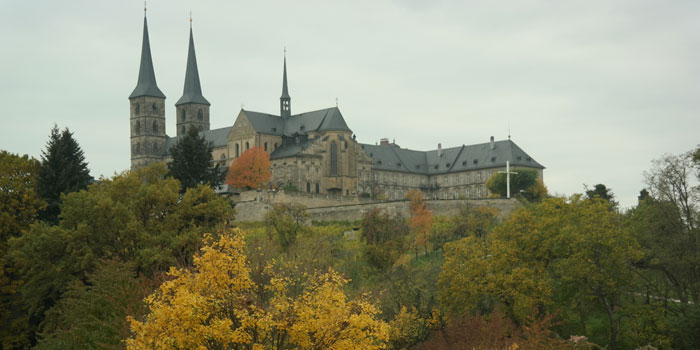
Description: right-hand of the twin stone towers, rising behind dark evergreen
xmin=175 ymin=19 xmax=211 ymax=136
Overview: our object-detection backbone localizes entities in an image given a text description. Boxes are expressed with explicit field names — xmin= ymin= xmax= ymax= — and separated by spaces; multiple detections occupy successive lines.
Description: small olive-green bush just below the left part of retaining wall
xmin=265 ymin=203 xmax=310 ymax=250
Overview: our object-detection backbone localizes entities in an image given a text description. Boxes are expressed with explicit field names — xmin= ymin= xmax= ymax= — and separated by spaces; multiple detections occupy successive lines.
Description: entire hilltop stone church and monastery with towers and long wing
xmin=129 ymin=16 xmax=544 ymax=199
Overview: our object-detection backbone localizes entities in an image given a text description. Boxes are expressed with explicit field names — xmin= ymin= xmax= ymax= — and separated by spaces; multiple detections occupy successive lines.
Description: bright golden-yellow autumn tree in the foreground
xmin=127 ymin=230 xmax=388 ymax=350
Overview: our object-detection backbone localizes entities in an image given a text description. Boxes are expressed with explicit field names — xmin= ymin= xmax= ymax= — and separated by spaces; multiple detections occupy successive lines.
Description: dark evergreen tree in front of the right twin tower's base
xmin=168 ymin=127 xmax=226 ymax=193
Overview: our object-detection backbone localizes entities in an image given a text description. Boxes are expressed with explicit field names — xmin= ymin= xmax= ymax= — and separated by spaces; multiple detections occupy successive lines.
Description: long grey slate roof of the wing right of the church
xmin=361 ymin=140 xmax=544 ymax=175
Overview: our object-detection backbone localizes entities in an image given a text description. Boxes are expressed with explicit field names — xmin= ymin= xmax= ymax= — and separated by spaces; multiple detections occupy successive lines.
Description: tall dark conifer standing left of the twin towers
xmin=37 ymin=125 xmax=92 ymax=224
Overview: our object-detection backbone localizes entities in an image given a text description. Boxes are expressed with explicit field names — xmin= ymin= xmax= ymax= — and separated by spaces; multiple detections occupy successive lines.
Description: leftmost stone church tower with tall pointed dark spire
xmin=129 ymin=13 xmax=166 ymax=169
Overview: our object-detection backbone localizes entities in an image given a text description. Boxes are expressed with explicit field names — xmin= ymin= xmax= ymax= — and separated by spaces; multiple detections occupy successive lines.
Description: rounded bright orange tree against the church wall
xmin=226 ymin=147 xmax=270 ymax=189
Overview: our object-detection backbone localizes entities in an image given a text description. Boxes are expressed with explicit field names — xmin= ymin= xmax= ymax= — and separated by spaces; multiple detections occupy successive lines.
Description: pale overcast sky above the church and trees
xmin=0 ymin=0 xmax=700 ymax=208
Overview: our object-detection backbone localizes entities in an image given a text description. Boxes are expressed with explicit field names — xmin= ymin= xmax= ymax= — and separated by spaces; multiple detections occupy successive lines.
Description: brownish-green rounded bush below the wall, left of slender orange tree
xmin=360 ymin=208 xmax=410 ymax=271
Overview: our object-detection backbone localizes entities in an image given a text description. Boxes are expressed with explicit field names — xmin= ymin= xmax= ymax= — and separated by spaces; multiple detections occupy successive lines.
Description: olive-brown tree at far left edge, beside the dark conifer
xmin=0 ymin=151 xmax=46 ymax=349
